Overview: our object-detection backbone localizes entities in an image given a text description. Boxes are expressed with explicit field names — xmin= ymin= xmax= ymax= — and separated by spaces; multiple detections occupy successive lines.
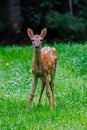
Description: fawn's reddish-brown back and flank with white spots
xmin=41 ymin=46 xmax=57 ymax=74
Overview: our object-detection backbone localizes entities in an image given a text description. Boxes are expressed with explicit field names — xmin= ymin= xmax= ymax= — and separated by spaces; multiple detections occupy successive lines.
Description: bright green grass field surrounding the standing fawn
xmin=0 ymin=43 xmax=87 ymax=130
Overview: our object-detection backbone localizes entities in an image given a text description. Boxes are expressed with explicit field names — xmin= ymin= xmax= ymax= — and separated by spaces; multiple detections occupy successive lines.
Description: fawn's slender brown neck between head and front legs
xmin=34 ymin=49 xmax=42 ymax=74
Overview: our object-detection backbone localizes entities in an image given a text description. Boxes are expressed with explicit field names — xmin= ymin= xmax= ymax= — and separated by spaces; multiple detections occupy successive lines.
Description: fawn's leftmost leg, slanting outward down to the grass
xmin=28 ymin=76 xmax=38 ymax=110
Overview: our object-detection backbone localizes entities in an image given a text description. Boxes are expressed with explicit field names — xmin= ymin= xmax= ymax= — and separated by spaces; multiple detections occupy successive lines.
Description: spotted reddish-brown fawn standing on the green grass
xmin=27 ymin=28 xmax=57 ymax=110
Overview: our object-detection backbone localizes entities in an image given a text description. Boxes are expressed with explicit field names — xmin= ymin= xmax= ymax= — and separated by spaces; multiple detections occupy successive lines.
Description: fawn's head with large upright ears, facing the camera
xmin=27 ymin=28 xmax=47 ymax=48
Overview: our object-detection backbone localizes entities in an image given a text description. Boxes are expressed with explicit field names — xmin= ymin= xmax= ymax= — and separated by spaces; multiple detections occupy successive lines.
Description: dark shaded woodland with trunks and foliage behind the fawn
xmin=0 ymin=0 xmax=87 ymax=45
